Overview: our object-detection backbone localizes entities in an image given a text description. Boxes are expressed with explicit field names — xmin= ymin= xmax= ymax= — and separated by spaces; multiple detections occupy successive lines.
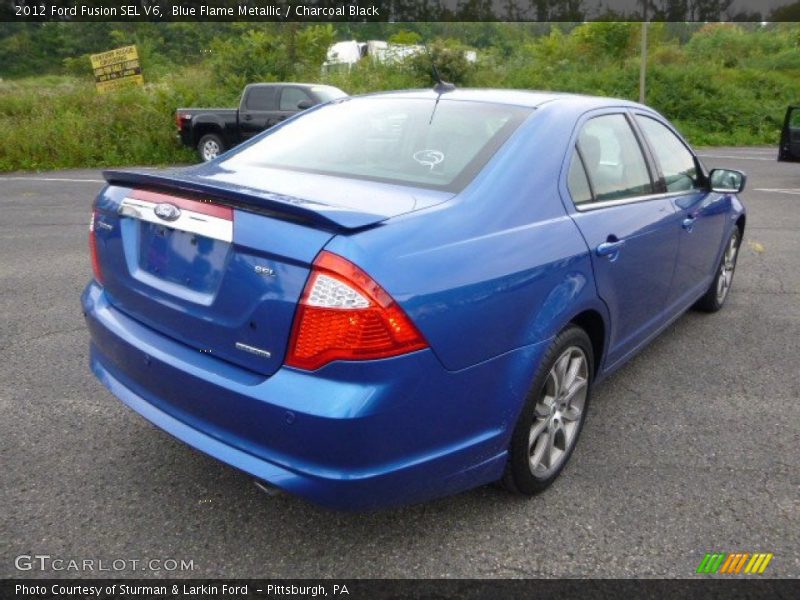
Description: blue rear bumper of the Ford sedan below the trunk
xmin=82 ymin=283 xmax=546 ymax=510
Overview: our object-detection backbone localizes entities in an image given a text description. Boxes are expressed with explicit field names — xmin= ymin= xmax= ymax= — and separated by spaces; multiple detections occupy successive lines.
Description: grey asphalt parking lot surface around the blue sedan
xmin=0 ymin=148 xmax=800 ymax=578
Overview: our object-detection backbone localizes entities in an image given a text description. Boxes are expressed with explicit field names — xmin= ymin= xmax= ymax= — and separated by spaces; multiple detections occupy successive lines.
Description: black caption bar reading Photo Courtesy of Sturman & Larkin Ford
xmin=0 ymin=576 xmax=800 ymax=600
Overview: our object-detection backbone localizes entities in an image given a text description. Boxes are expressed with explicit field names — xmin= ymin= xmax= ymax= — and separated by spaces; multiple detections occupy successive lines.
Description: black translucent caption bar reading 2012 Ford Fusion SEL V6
xmin=0 ymin=0 xmax=800 ymax=22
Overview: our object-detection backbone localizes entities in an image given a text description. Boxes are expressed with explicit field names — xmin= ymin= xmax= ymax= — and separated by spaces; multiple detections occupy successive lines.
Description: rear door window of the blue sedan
xmin=578 ymin=115 xmax=653 ymax=202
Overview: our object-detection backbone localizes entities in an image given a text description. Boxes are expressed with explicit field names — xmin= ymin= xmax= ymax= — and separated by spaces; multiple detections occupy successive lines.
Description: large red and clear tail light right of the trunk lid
xmin=286 ymin=250 xmax=428 ymax=370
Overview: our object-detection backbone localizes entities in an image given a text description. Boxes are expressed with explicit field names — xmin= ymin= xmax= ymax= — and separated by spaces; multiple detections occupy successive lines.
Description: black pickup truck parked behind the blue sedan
xmin=175 ymin=83 xmax=347 ymax=161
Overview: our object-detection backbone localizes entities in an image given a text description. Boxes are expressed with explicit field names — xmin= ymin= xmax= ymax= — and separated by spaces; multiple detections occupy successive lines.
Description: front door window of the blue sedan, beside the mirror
xmin=636 ymin=115 xmax=700 ymax=192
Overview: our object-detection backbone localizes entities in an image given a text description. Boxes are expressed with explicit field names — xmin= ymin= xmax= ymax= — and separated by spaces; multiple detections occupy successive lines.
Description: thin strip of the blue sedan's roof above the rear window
xmin=354 ymin=88 xmax=652 ymax=111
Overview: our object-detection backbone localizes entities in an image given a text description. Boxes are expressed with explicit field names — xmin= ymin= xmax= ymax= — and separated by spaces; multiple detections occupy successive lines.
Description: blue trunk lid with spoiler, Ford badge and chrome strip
xmin=95 ymin=171 xmax=450 ymax=376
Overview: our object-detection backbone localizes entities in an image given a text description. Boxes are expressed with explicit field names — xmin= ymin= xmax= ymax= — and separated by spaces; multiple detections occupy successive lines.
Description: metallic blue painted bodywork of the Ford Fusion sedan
xmin=82 ymin=91 xmax=744 ymax=509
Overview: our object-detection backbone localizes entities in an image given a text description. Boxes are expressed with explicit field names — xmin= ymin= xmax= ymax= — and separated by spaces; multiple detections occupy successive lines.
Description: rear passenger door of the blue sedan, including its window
xmin=567 ymin=111 xmax=678 ymax=368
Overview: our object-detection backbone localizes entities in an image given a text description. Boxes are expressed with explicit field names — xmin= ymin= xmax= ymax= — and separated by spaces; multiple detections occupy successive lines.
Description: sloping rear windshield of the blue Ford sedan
xmin=222 ymin=97 xmax=532 ymax=191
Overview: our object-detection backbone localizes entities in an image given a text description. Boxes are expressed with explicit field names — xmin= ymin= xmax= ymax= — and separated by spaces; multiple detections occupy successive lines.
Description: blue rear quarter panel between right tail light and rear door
xmin=327 ymin=108 xmax=604 ymax=371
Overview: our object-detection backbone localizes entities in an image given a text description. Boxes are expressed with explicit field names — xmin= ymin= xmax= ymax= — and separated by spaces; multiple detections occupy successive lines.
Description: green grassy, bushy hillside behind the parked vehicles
xmin=0 ymin=23 xmax=800 ymax=171
